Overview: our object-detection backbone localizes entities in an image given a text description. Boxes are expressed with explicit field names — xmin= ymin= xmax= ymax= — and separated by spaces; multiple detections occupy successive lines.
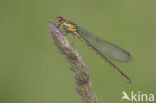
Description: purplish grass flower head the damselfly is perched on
xmin=49 ymin=21 xmax=98 ymax=103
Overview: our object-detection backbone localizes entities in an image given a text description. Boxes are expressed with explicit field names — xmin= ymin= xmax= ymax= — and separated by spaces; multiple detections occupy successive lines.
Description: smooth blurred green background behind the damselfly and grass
xmin=0 ymin=0 xmax=156 ymax=103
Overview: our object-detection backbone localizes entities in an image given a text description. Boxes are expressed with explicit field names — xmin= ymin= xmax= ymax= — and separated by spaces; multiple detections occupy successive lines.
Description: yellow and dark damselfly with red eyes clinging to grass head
xmin=56 ymin=17 xmax=132 ymax=83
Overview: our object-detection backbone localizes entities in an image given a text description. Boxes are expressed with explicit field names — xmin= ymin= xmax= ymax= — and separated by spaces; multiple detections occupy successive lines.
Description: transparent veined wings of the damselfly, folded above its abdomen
xmin=77 ymin=26 xmax=132 ymax=62
